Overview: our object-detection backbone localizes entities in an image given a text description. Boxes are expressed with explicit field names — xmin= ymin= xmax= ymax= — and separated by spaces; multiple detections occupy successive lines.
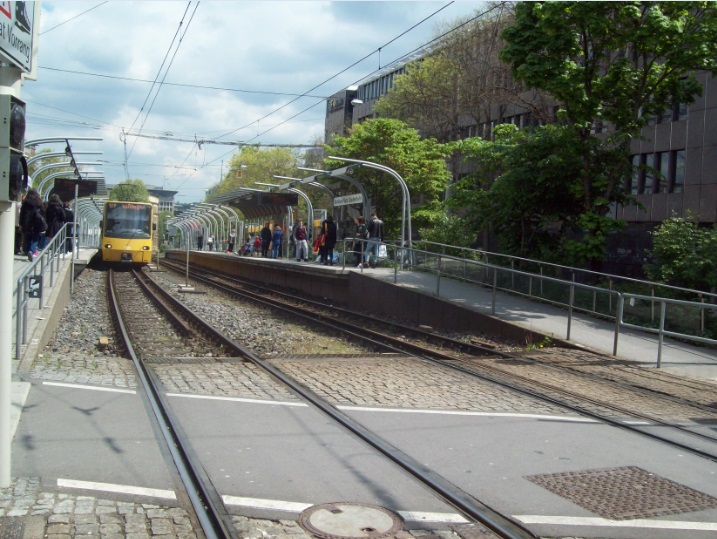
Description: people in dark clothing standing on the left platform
xmin=15 ymin=189 xmax=75 ymax=262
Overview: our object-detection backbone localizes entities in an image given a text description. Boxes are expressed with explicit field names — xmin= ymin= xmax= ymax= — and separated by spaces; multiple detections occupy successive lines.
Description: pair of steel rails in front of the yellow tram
xmin=109 ymin=272 xmax=535 ymax=539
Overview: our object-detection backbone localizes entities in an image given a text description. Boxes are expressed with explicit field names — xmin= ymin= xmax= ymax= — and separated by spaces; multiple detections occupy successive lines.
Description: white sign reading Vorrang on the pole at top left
xmin=0 ymin=2 xmax=39 ymax=73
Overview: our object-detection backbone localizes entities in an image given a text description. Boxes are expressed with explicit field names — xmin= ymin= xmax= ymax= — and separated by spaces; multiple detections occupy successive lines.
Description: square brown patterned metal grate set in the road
xmin=526 ymin=466 xmax=717 ymax=520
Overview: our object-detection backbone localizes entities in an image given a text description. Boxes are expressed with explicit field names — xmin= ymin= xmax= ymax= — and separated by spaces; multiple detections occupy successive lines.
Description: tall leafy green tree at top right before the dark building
xmin=501 ymin=2 xmax=717 ymax=260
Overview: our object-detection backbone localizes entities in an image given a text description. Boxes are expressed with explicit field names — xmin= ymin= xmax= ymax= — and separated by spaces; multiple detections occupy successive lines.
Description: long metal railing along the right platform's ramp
xmin=342 ymin=240 xmax=717 ymax=367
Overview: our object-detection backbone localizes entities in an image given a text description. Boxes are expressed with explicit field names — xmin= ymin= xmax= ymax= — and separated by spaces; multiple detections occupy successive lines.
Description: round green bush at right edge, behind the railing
xmin=645 ymin=215 xmax=717 ymax=292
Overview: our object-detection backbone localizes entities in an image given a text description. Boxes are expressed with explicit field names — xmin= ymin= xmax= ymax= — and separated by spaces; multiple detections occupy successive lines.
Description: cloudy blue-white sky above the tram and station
xmin=21 ymin=0 xmax=484 ymax=202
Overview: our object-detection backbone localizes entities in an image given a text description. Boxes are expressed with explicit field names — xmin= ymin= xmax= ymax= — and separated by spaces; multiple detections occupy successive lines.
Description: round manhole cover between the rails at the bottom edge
xmin=299 ymin=502 xmax=403 ymax=539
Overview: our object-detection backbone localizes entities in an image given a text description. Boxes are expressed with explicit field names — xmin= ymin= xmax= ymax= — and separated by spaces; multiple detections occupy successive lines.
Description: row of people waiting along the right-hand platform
xmin=197 ymin=212 xmax=384 ymax=268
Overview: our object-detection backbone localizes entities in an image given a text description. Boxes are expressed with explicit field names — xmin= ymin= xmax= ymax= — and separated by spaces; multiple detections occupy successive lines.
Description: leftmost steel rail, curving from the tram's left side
xmin=108 ymin=270 xmax=235 ymax=539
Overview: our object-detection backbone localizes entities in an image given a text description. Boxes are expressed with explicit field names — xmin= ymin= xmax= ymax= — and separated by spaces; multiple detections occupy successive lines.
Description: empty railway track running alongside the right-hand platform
xmin=158 ymin=263 xmax=717 ymax=461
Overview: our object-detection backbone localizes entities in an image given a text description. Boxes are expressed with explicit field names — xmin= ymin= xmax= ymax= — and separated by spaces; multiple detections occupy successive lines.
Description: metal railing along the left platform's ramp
xmin=12 ymin=223 xmax=78 ymax=360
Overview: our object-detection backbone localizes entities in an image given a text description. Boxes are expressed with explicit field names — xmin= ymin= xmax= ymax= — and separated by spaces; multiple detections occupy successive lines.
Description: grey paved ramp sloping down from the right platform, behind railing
xmin=364 ymin=268 xmax=717 ymax=382
